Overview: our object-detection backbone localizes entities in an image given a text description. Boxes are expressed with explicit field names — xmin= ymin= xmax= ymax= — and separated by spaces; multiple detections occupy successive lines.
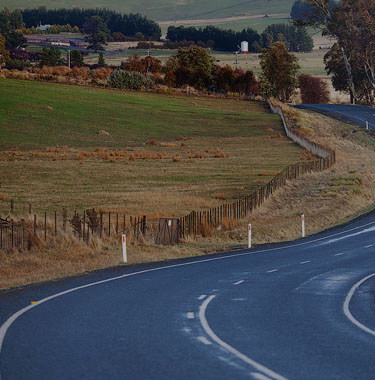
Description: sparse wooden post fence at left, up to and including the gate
xmin=0 ymin=209 xmax=180 ymax=251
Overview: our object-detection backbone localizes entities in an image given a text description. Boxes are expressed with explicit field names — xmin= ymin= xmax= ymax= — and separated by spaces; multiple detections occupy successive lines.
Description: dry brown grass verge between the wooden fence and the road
xmin=0 ymin=108 xmax=375 ymax=288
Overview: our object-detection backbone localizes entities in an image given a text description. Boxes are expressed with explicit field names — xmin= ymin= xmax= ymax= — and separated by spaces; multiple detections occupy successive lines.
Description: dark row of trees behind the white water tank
xmin=167 ymin=24 xmax=314 ymax=53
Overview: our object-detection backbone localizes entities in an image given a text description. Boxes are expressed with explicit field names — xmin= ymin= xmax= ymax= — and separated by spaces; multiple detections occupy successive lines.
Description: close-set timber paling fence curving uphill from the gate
xmin=180 ymin=100 xmax=336 ymax=238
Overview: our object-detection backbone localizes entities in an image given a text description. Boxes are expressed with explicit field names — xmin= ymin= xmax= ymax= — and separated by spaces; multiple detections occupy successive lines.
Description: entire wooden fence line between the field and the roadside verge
xmin=0 ymin=100 xmax=336 ymax=250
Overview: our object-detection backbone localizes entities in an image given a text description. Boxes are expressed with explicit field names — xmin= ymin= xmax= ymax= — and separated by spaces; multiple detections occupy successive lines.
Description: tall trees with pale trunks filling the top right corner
xmin=294 ymin=0 xmax=375 ymax=104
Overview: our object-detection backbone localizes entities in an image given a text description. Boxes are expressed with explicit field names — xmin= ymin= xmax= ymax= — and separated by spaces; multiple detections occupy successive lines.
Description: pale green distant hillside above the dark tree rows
xmin=0 ymin=0 xmax=294 ymax=21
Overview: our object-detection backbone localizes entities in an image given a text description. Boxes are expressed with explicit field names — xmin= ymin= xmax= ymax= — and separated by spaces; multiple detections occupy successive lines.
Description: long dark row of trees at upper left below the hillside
xmin=22 ymin=7 xmax=161 ymax=40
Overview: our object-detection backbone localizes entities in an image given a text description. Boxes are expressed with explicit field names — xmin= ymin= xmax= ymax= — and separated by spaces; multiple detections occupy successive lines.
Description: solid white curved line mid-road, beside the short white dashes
xmin=199 ymin=295 xmax=287 ymax=380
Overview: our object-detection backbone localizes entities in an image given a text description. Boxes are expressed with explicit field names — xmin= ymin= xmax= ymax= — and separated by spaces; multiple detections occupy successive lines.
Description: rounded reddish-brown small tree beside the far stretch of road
xmin=298 ymin=74 xmax=329 ymax=104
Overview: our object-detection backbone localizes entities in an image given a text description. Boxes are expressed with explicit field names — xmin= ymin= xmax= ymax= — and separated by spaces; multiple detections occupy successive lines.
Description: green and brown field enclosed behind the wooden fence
xmin=0 ymin=80 xmax=311 ymax=218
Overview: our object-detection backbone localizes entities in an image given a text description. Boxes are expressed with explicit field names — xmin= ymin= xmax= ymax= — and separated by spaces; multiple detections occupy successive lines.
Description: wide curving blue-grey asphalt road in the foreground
xmin=0 ymin=215 xmax=375 ymax=380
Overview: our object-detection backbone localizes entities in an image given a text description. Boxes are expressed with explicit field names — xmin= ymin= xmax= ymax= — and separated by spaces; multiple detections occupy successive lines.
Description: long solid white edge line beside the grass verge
xmin=0 ymin=218 xmax=375 ymax=380
